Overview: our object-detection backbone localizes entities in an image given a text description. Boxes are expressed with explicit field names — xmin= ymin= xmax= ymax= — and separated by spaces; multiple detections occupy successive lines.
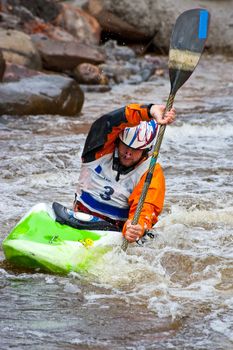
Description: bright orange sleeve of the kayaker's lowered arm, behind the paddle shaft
xmin=123 ymin=164 xmax=165 ymax=234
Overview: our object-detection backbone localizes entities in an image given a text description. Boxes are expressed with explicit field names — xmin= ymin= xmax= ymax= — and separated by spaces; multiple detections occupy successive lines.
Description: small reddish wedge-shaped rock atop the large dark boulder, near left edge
xmin=3 ymin=63 xmax=45 ymax=83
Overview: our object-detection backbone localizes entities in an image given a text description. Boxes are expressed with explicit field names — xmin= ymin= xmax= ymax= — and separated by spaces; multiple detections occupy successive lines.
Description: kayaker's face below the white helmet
xmin=118 ymin=141 xmax=143 ymax=167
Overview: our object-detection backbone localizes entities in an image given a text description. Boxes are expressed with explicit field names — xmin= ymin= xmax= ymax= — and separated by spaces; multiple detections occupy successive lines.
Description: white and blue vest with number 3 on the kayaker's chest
xmin=77 ymin=154 xmax=150 ymax=221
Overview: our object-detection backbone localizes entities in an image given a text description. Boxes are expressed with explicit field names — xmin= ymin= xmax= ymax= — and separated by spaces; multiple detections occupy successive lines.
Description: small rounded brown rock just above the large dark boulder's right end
xmin=73 ymin=63 xmax=108 ymax=85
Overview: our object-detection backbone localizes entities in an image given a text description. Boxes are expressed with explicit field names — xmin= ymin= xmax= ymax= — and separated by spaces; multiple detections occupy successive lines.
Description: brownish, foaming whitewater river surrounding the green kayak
xmin=0 ymin=56 xmax=233 ymax=350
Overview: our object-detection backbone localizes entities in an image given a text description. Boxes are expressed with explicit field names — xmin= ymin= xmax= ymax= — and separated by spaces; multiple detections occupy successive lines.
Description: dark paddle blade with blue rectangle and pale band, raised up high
xmin=168 ymin=9 xmax=210 ymax=95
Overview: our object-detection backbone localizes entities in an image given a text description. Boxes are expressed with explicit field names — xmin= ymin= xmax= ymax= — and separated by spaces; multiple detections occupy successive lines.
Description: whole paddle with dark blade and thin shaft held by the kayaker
xmin=121 ymin=8 xmax=209 ymax=251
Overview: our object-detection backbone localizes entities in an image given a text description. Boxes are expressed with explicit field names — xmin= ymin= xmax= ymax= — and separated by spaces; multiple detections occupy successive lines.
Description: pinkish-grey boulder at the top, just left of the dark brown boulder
xmin=55 ymin=3 xmax=101 ymax=45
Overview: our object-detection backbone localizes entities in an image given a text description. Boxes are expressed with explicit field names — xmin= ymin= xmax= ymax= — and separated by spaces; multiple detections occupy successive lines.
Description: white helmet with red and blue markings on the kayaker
xmin=119 ymin=119 xmax=157 ymax=149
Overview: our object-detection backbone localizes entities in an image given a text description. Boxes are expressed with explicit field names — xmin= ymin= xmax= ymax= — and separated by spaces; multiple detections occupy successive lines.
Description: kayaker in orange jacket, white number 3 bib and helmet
xmin=74 ymin=104 xmax=176 ymax=243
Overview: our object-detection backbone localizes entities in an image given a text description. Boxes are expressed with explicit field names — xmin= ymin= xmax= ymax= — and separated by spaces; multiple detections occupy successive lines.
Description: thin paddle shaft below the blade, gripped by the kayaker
xmin=121 ymin=93 xmax=175 ymax=251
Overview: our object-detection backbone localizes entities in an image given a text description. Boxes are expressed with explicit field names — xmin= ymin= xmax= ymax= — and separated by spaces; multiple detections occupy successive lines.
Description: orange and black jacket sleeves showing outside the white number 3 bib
xmin=82 ymin=104 xmax=165 ymax=232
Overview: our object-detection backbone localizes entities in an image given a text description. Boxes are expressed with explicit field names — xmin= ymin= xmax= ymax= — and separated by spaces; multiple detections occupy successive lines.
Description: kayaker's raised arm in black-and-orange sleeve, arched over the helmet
xmin=82 ymin=104 xmax=152 ymax=163
